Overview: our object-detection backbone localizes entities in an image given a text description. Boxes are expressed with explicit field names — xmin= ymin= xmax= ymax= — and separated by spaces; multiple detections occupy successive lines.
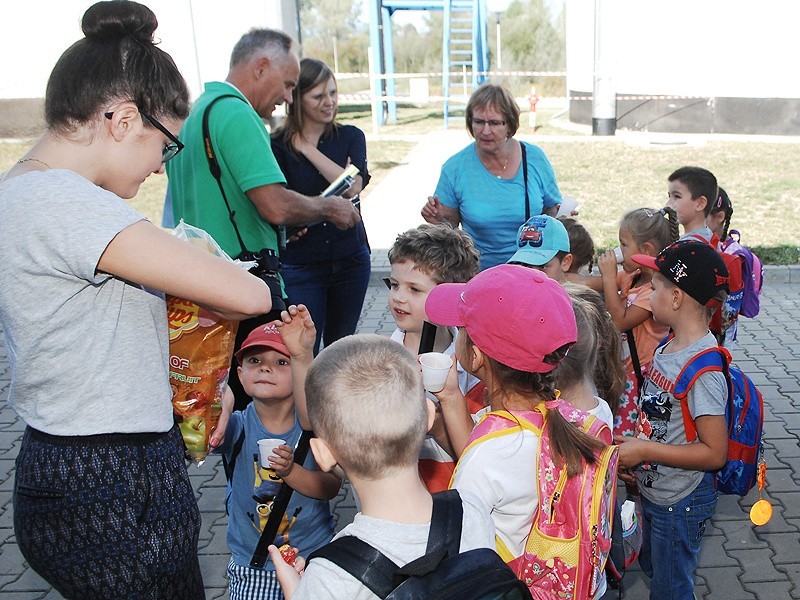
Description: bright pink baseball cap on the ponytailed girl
xmin=425 ymin=265 xmax=578 ymax=373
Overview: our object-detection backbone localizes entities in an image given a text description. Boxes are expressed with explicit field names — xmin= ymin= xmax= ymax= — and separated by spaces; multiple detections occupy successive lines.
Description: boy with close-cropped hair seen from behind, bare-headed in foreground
xmin=270 ymin=334 xmax=495 ymax=600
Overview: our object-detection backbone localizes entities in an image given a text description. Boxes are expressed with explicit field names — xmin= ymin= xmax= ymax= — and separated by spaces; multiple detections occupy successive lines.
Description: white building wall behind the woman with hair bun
xmin=0 ymin=0 xmax=297 ymax=137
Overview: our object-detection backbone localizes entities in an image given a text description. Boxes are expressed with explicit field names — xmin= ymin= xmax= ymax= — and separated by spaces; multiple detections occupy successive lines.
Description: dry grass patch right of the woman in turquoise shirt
xmin=538 ymin=139 xmax=800 ymax=264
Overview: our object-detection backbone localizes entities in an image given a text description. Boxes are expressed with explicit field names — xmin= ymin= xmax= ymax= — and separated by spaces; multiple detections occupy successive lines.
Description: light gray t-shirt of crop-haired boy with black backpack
xmin=292 ymin=492 xmax=495 ymax=600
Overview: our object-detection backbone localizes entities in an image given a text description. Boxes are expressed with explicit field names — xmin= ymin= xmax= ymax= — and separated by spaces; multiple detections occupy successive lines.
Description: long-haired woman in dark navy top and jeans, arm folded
xmin=272 ymin=58 xmax=370 ymax=353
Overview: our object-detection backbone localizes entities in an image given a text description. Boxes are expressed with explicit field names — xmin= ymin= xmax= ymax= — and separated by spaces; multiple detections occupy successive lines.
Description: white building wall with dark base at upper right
xmin=567 ymin=0 xmax=800 ymax=134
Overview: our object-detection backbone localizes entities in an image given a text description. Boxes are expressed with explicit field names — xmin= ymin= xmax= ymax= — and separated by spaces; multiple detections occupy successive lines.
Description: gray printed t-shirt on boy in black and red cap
xmin=636 ymin=333 xmax=728 ymax=506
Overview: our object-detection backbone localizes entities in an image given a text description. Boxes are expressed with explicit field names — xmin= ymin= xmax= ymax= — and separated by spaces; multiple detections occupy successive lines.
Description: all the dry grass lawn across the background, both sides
xmin=6 ymin=112 xmax=800 ymax=264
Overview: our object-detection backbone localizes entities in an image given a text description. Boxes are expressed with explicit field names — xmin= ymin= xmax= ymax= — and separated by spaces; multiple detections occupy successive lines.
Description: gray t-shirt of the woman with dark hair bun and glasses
xmin=0 ymin=169 xmax=172 ymax=436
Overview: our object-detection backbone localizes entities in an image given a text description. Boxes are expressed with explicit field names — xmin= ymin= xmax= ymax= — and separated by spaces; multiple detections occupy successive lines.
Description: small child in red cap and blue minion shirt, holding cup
xmin=215 ymin=324 xmax=342 ymax=599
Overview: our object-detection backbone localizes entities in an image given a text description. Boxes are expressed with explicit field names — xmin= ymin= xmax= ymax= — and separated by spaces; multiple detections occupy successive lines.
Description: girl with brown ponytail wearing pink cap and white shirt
xmin=425 ymin=264 xmax=611 ymax=597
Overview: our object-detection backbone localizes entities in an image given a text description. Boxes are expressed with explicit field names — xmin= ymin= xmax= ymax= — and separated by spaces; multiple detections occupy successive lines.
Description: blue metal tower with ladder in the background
xmin=369 ymin=0 xmax=489 ymax=127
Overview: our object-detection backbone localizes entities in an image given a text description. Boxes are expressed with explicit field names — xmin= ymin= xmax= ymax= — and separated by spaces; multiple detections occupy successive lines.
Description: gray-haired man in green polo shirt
xmin=167 ymin=29 xmax=360 ymax=409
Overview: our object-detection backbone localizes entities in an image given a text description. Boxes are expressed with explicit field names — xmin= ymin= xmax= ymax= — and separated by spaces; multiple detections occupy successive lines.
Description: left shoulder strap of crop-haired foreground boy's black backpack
xmin=308 ymin=535 xmax=400 ymax=598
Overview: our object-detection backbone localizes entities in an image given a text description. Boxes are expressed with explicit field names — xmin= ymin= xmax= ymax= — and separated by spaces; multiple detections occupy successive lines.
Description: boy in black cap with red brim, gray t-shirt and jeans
xmin=617 ymin=241 xmax=728 ymax=600
